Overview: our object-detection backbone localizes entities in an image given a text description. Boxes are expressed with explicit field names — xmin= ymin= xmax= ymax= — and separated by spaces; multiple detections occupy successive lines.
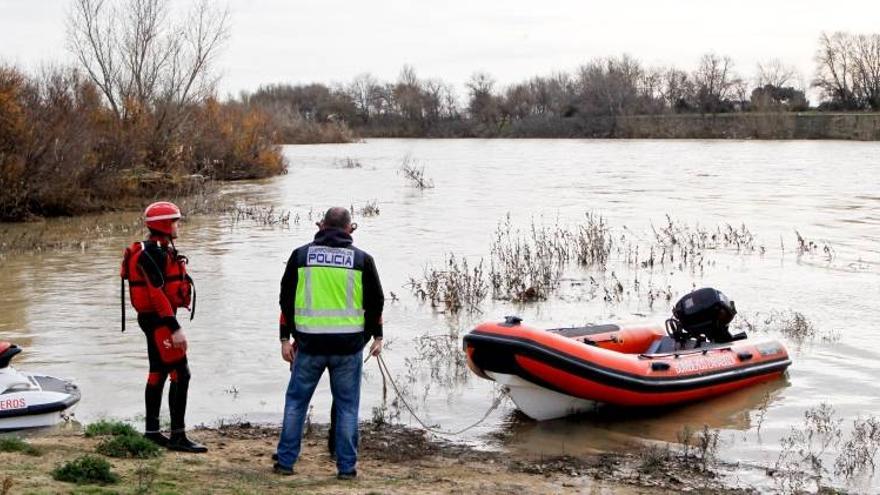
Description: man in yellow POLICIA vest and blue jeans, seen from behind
xmin=274 ymin=207 xmax=385 ymax=479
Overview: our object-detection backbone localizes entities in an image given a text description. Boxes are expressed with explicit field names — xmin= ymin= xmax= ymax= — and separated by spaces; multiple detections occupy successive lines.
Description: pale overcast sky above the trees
xmin=0 ymin=0 xmax=880 ymax=94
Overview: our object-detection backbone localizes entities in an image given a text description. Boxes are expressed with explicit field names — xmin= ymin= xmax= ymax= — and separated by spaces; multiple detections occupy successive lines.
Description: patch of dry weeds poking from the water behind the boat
xmin=408 ymin=213 xmax=815 ymax=314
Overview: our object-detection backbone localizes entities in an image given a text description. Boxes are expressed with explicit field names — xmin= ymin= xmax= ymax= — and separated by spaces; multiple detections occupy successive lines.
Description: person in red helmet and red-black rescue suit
xmin=121 ymin=201 xmax=208 ymax=453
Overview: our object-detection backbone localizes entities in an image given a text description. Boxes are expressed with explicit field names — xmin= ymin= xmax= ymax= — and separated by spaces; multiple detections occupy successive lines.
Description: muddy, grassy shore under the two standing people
xmin=0 ymin=423 xmax=755 ymax=495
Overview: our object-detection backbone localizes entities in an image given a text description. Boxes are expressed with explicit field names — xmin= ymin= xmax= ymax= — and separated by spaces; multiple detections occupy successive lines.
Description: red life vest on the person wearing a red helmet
xmin=119 ymin=240 xmax=195 ymax=332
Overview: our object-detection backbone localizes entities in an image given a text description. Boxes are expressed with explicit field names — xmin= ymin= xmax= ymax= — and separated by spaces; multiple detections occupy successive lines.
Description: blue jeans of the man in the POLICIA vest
xmin=278 ymin=351 xmax=363 ymax=473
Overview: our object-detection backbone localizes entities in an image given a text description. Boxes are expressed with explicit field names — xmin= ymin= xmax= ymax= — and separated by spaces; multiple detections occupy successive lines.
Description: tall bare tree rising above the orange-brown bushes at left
xmin=67 ymin=0 xmax=229 ymax=124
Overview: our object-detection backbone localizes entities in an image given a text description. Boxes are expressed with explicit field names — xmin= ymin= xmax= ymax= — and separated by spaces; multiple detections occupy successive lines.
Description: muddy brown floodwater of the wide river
xmin=0 ymin=140 xmax=880 ymax=488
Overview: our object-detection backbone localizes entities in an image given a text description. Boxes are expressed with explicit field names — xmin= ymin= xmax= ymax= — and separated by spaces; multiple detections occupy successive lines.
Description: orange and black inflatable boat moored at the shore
xmin=464 ymin=318 xmax=791 ymax=420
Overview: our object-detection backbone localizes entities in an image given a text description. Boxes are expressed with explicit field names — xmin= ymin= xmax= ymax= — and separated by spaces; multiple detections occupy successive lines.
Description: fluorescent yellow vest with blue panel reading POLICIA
xmin=293 ymin=246 xmax=364 ymax=334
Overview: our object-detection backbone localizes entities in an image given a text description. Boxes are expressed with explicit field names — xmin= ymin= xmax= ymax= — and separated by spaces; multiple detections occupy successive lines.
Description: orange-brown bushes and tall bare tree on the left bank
xmin=0 ymin=0 xmax=286 ymax=220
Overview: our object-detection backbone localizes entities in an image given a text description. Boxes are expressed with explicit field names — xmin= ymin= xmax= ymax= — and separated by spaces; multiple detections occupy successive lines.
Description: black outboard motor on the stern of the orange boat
xmin=666 ymin=287 xmax=746 ymax=343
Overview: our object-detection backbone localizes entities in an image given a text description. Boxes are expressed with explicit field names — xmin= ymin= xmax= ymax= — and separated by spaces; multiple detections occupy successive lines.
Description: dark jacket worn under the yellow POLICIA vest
xmin=278 ymin=229 xmax=385 ymax=354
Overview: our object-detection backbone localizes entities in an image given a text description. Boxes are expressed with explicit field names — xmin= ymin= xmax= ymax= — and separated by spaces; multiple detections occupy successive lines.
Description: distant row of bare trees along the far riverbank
xmin=239 ymin=32 xmax=880 ymax=137
